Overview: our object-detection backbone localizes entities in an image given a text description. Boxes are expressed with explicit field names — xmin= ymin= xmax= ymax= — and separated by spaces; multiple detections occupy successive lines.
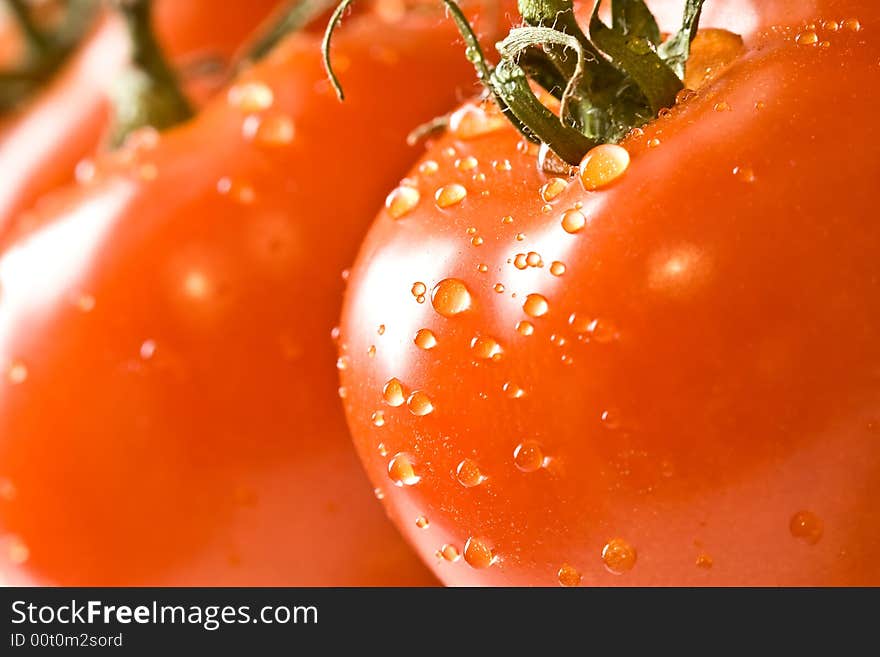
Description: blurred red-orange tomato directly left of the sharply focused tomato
xmin=0 ymin=10 xmax=502 ymax=585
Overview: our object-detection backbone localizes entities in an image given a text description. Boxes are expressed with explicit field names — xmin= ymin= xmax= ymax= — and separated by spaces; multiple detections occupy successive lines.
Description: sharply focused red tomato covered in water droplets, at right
xmin=340 ymin=1 xmax=880 ymax=585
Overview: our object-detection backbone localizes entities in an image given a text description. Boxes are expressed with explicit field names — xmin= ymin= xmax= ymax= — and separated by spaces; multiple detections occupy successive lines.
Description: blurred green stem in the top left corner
xmin=0 ymin=0 xmax=98 ymax=112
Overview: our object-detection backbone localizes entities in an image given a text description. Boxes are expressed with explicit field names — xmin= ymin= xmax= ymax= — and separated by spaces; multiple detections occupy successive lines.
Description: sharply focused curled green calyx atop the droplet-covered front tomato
xmin=443 ymin=0 xmax=704 ymax=164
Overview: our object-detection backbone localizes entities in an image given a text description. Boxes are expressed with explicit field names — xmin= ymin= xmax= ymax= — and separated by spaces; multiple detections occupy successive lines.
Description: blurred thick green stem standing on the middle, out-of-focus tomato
xmin=111 ymin=0 xmax=193 ymax=146
